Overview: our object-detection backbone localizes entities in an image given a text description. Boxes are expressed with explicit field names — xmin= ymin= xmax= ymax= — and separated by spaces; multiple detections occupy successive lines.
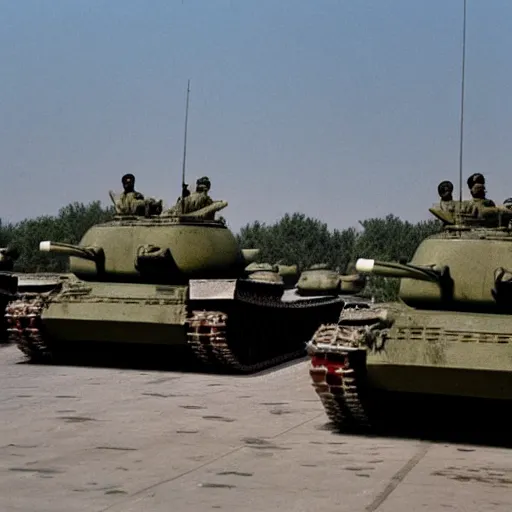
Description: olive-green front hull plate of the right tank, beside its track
xmin=367 ymin=310 xmax=512 ymax=400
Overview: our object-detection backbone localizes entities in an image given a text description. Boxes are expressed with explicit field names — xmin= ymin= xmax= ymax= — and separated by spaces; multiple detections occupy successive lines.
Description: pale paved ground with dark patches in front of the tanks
xmin=0 ymin=347 xmax=512 ymax=512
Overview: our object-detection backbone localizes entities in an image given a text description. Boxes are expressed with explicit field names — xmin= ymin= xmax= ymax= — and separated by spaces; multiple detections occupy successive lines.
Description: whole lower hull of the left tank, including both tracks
xmin=7 ymin=279 xmax=352 ymax=373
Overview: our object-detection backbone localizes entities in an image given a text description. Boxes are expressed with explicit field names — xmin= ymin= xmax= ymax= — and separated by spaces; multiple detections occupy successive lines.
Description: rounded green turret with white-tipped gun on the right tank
xmin=356 ymin=202 xmax=512 ymax=312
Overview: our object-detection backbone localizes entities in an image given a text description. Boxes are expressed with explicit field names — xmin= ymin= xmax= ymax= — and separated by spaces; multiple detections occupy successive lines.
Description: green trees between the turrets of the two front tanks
xmin=239 ymin=213 xmax=441 ymax=301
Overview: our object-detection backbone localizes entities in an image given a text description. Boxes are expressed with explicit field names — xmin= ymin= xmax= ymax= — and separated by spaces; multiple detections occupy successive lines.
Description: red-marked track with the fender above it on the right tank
xmin=307 ymin=308 xmax=390 ymax=431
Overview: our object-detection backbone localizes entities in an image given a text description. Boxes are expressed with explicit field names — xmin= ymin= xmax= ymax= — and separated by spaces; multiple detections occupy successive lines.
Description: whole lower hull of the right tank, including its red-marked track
xmin=308 ymin=305 xmax=512 ymax=430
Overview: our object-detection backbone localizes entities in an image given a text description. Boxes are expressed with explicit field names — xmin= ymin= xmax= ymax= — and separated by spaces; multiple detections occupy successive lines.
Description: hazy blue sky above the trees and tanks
xmin=0 ymin=0 xmax=512 ymax=230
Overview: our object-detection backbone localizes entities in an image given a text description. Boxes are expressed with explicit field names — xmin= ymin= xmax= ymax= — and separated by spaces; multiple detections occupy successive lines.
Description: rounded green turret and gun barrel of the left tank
xmin=39 ymin=209 xmax=250 ymax=284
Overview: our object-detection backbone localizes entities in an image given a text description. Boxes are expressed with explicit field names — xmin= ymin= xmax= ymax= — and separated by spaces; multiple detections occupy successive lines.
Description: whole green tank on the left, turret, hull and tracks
xmin=6 ymin=196 xmax=364 ymax=373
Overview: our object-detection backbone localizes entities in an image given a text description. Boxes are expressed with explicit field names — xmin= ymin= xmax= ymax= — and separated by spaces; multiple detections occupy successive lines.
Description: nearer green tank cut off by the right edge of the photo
xmin=307 ymin=201 xmax=512 ymax=430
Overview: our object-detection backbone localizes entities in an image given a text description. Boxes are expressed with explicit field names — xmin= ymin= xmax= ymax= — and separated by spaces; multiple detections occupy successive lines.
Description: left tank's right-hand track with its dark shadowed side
xmin=187 ymin=283 xmax=344 ymax=373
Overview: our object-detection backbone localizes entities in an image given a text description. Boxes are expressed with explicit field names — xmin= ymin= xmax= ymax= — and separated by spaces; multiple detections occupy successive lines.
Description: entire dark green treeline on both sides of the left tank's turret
xmin=0 ymin=201 xmax=440 ymax=300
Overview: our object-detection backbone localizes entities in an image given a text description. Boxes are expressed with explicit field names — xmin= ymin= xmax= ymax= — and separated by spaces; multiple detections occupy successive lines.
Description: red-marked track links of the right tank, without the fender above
xmin=308 ymin=324 xmax=371 ymax=431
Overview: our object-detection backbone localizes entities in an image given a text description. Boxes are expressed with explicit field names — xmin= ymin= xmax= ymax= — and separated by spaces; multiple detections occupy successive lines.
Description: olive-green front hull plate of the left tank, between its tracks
xmin=41 ymin=283 xmax=188 ymax=344
